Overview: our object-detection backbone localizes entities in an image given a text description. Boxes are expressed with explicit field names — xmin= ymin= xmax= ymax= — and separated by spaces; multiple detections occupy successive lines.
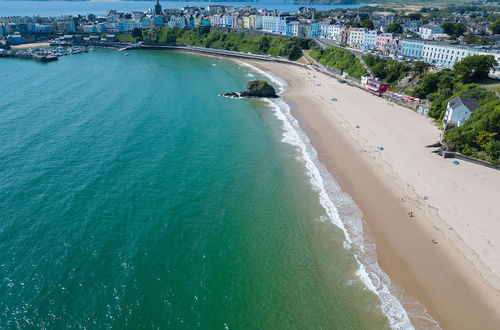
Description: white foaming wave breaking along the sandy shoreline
xmin=240 ymin=63 xmax=439 ymax=329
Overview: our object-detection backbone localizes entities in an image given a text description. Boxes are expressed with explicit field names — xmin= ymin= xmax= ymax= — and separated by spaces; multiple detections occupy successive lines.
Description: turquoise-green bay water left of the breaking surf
xmin=0 ymin=50 xmax=400 ymax=329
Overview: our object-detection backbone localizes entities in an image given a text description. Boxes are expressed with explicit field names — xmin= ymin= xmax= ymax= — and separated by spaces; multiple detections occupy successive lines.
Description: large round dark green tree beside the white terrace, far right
xmin=453 ymin=55 xmax=498 ymax=83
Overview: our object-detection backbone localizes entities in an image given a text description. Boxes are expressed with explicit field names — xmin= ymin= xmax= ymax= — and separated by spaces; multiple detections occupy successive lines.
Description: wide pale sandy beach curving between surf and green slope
xmin=250 ymin=62 xmax=500 ymax=329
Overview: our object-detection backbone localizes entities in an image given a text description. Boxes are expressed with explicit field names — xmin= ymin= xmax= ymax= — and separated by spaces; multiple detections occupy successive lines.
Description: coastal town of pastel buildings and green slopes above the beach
xmin=0 ymin=0 xmax=500 ymax=163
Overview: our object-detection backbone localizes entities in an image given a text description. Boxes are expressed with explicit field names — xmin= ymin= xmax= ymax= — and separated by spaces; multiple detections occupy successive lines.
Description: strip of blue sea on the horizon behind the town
xmin=0 ymin=0 xmax=361 ymax=17
